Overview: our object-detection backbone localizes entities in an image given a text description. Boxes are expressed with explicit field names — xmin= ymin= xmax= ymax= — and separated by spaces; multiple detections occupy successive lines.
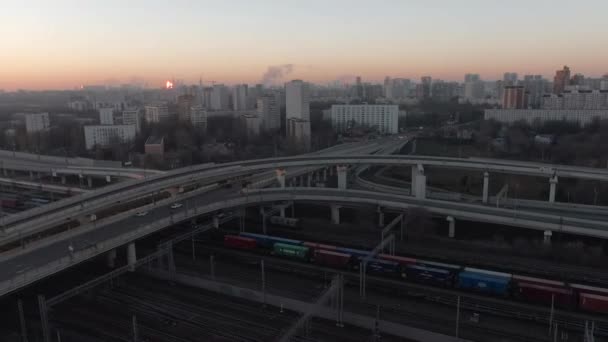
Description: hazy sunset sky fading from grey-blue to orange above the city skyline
xmin=0 ymin=0 xmax=608 ymax=90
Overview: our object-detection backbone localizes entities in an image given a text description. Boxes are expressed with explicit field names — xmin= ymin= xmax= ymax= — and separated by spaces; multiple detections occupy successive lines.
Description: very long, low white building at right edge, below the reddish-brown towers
xmin=484 ymin=109 xmax=608 ymax=126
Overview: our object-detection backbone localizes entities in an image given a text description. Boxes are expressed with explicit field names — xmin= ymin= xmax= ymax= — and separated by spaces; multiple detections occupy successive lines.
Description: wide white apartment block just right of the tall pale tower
xmin=331 ymin=104 xmax=399 ymax=134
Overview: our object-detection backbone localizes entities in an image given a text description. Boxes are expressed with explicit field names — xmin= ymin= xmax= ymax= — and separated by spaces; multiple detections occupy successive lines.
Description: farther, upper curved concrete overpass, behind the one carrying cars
xmin=2 ymin=155 xmax=608 ymax=241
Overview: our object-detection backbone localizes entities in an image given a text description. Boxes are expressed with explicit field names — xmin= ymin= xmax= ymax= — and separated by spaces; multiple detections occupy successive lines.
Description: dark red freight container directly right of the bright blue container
xmin=512 ymin=275 xmax=575 ymax=307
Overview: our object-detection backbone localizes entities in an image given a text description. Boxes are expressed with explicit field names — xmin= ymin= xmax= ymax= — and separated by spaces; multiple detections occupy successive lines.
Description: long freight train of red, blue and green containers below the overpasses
xmin=223 ymin=233 xmax=608 ymax=314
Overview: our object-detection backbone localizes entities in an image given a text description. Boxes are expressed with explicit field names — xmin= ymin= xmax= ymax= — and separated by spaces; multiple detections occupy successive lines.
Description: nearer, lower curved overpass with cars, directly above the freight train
xmin=0 ymin=188 xmax=608 ymax=296
